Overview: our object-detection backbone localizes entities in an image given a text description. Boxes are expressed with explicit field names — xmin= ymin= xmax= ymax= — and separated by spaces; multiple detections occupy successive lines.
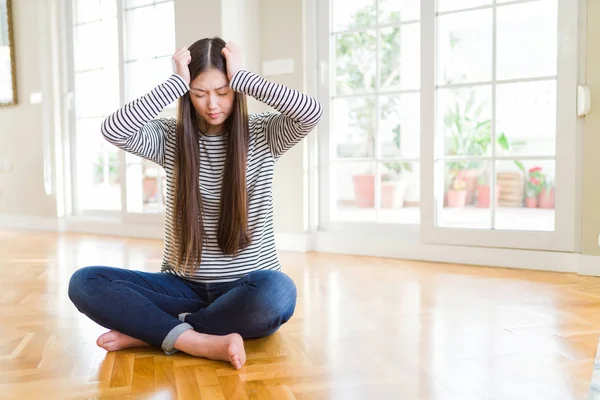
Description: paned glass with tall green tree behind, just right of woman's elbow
xmin=327 ymin=0 xmax=421 ymax=224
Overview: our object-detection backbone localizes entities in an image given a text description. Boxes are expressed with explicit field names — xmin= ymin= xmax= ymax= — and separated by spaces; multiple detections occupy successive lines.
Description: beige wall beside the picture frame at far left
xmin=0 ymin=0 xmax=56 ymax=217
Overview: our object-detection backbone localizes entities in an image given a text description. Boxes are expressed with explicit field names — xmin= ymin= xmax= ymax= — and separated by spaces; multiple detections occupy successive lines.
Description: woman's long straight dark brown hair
xmin=172 ymin=38 xmax=250 ymax=272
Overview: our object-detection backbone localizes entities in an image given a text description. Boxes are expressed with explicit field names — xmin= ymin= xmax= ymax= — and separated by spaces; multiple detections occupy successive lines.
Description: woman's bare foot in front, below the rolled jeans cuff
xmin=175 ymin=329 xmax=246 ymax=369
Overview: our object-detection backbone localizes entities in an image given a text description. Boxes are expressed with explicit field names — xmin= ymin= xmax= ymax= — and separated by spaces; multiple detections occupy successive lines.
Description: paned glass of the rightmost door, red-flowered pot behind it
xmin=434 ymin=0 xmax=558 ymax=231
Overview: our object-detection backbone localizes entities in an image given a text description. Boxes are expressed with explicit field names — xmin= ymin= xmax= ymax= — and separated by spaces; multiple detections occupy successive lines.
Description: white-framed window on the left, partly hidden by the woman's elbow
xmin=73 ymin=0 xmax=175 ymax=214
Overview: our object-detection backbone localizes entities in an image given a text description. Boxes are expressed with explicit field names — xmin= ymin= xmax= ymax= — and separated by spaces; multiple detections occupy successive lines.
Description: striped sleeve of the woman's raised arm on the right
xmin=230 ymin=70 xmax=323 ymax=158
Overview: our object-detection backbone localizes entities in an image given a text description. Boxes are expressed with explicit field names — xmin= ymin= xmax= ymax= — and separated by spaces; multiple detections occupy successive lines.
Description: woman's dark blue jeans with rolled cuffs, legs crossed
xmin=69 ymin=266 xmax=296 ymax=354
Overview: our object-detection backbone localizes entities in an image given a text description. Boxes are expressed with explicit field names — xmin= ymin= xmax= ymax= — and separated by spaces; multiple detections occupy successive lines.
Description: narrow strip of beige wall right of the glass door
xmin=582 ymin=0 xmax=600 ymax=255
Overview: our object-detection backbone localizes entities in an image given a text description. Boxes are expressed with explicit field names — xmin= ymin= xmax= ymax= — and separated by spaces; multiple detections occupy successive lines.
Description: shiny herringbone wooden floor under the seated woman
xmin=0 ymin=232 xmax=600 ymax=400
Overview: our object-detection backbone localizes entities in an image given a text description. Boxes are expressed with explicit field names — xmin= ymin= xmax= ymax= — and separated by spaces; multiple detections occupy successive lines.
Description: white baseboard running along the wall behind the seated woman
xmin=0 ymin=215 xmax=600 ymax=276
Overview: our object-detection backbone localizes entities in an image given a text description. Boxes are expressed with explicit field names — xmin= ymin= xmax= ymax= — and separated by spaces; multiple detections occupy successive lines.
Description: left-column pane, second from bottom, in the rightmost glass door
xmin=436 ymin=86 xmax=492 ymax=156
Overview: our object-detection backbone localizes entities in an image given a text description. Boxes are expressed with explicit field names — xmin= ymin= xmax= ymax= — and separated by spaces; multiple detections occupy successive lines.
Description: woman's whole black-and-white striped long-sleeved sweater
xmin=101 ymin=70 xmax=322 ymax=283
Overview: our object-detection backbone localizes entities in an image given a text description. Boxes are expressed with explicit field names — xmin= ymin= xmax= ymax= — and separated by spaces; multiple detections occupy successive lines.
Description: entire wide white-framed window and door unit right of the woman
xmin=317 ymin=0 xmax=579 ymax=251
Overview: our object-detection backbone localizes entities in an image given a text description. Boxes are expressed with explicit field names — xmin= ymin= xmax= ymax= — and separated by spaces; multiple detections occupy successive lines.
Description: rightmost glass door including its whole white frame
xmin=421 ymin=0 xmax=578 ymax=251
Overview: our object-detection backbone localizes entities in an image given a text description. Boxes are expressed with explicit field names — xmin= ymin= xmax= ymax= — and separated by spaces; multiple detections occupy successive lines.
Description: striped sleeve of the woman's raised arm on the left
xmin=101 ymin=74 xmax=189 ymax=166
